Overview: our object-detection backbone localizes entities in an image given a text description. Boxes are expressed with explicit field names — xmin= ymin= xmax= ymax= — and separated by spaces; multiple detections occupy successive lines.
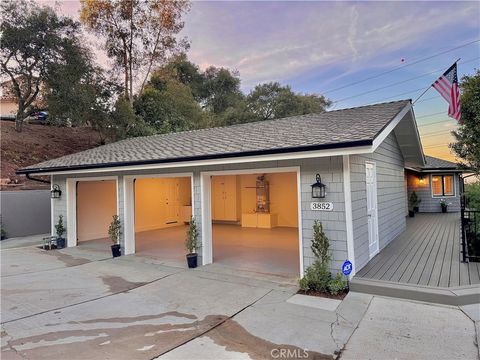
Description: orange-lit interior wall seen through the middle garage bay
xmin=135 ymin=177 xmax=192 ymax=231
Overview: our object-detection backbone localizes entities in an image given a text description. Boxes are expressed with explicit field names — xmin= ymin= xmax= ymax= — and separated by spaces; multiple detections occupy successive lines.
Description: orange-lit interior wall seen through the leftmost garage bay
xmin=77 ymin=180 xmax=117 ymax=241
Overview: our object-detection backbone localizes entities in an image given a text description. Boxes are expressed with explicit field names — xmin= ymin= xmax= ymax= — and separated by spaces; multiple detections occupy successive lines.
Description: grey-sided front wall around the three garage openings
xmin=53 ymin=156 xmax=347 ymax=270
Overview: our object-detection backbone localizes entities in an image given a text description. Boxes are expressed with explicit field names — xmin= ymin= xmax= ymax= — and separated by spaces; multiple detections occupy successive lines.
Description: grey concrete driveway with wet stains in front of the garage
xmin=1 ymin=236 xmax=479 ymax=360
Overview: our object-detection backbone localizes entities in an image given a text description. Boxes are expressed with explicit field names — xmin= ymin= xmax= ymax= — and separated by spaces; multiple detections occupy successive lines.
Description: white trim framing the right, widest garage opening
xmin=200 ymin=166 xmax=304 ymax=277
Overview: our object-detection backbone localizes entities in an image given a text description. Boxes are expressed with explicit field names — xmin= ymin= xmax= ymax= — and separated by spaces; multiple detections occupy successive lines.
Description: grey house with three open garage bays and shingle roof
xmin=18 ymin=100 xmax=474 ymax=292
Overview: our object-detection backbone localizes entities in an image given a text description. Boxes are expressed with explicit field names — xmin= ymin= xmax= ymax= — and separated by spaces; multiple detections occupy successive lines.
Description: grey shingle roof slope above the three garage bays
xmin=18 ymin=100 xmax=410 ymax=173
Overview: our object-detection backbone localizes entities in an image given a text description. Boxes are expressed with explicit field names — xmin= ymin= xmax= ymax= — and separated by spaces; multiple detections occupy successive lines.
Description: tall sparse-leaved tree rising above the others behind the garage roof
xmin=80 ymin=0 xmax=189 ymax=104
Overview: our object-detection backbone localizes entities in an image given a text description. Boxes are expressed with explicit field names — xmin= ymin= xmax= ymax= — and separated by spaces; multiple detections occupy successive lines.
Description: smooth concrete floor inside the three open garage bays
xmin=79 ymin=224 xmax=300 ymax=279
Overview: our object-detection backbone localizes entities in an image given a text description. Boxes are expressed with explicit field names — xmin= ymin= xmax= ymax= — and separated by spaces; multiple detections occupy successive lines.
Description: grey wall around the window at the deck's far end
xmin=407 ymin=171 xmax=461 ymax=212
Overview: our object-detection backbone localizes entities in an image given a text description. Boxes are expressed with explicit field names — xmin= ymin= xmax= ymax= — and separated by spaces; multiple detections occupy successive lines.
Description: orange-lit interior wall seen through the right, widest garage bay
xmin=238 ymin=173 xmax=298 ymax=227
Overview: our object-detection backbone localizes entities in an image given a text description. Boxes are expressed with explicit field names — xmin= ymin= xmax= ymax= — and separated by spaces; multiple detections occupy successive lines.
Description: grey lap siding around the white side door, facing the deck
xmin=350 ymin=133 xmax=406 ymax=272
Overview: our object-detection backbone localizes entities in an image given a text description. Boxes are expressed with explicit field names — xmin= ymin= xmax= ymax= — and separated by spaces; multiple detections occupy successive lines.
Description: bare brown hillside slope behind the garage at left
xmin=0 ymin=121 xmax=101 ymax=190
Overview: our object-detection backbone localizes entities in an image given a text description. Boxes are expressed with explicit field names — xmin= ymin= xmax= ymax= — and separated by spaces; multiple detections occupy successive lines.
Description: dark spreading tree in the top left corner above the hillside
xmin=0 ymin=0 xmax=79 ymax=131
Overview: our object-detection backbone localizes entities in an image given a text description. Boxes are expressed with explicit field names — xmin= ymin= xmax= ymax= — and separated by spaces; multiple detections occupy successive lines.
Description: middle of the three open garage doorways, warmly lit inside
xmin=134 ymin=177 xmax=192 ymax=264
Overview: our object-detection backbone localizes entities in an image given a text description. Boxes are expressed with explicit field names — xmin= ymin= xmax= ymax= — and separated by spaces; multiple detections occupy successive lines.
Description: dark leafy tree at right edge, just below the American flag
xmin=450 ymin=70 xmax=480 ymax=174
